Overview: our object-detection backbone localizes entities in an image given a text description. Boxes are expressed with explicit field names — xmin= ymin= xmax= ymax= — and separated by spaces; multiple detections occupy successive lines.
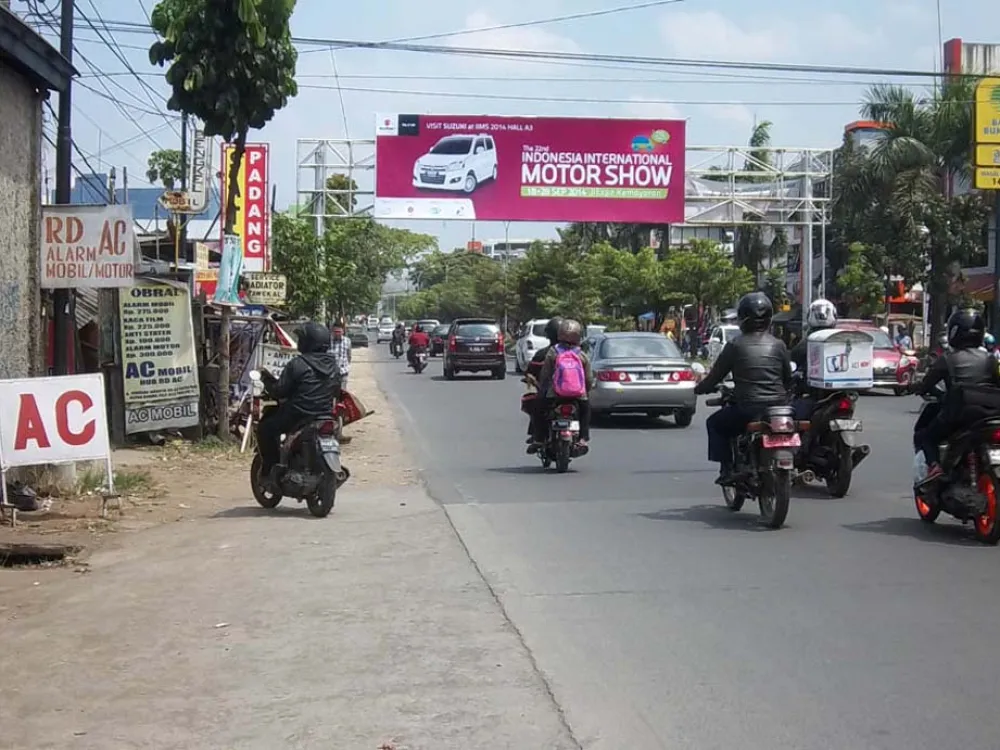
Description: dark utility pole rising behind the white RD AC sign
xmin=52 ymin=0 xmax=73 ymax=375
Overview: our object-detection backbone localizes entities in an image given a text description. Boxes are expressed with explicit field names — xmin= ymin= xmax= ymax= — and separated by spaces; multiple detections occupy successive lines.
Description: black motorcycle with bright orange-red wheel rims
xmin=913 ymin=388 xmax=1000 ymax=545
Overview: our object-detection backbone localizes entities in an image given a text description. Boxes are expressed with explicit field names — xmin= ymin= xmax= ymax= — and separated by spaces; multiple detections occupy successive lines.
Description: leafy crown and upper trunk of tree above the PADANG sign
xmin=149 ymin=0 xmax=298 ymax=231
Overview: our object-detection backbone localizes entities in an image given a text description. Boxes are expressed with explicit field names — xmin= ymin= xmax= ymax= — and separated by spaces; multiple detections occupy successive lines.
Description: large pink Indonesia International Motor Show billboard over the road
xmin=375 ymin=115 xmax=684 ymax=224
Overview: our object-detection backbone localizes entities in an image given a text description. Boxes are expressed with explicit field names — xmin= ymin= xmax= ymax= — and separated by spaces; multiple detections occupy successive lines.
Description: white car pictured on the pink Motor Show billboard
xmin=413 ymin=134 xmax=497 ymax=195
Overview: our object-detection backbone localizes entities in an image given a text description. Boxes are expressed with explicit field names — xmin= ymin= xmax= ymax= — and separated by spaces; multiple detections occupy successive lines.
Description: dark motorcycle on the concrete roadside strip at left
xmin=250 ymin=370 xmax=350 ymax=518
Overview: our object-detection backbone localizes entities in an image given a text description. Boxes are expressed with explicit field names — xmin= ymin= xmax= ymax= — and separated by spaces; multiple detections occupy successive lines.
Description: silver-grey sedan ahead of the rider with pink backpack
xmin=590 ymin=331 xmax=703 ymax=427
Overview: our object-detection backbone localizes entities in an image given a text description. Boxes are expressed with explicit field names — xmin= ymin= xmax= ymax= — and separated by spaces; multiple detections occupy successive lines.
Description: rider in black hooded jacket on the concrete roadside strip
xmin=257 ymin=321 xmax=340 ymax=483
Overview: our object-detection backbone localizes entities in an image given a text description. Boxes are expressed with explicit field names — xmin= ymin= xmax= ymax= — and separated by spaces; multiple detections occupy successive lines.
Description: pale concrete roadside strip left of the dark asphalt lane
xmin=0 ymin=352 xmax=577 ymax=750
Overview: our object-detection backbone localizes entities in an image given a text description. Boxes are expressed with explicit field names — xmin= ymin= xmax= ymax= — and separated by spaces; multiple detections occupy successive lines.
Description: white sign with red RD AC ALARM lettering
xmin=39 ymin=204 xmax=136 ymax=289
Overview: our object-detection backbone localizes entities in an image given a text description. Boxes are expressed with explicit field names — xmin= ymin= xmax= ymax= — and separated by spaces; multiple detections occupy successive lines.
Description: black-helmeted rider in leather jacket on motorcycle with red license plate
xmin=695 ymin=292 xmax=792 ymax=485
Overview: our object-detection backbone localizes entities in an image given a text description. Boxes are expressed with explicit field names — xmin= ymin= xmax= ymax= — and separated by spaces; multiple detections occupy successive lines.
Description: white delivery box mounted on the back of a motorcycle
xmin=806 ymin=328 xmax=875 ymax=390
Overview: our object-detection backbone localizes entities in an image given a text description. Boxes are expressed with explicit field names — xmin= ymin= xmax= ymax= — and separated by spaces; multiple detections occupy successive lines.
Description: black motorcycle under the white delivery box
xmin=795 ymin=390 xmax=871 ymax=497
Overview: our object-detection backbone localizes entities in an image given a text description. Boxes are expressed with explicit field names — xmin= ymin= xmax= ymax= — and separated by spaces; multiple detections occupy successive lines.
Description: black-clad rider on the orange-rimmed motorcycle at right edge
xmin=913 ymin=309 xmax=1000 ymax=484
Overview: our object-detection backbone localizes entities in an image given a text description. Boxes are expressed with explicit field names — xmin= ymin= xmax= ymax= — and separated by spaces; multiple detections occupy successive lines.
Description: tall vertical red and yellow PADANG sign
xmin=221 ymin=143 xmax=271 ymax=271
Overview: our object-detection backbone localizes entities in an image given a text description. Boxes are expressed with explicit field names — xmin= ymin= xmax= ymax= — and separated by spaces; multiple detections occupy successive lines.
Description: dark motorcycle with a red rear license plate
xmin=706 ymin=385 xmax=806 ymax=529
